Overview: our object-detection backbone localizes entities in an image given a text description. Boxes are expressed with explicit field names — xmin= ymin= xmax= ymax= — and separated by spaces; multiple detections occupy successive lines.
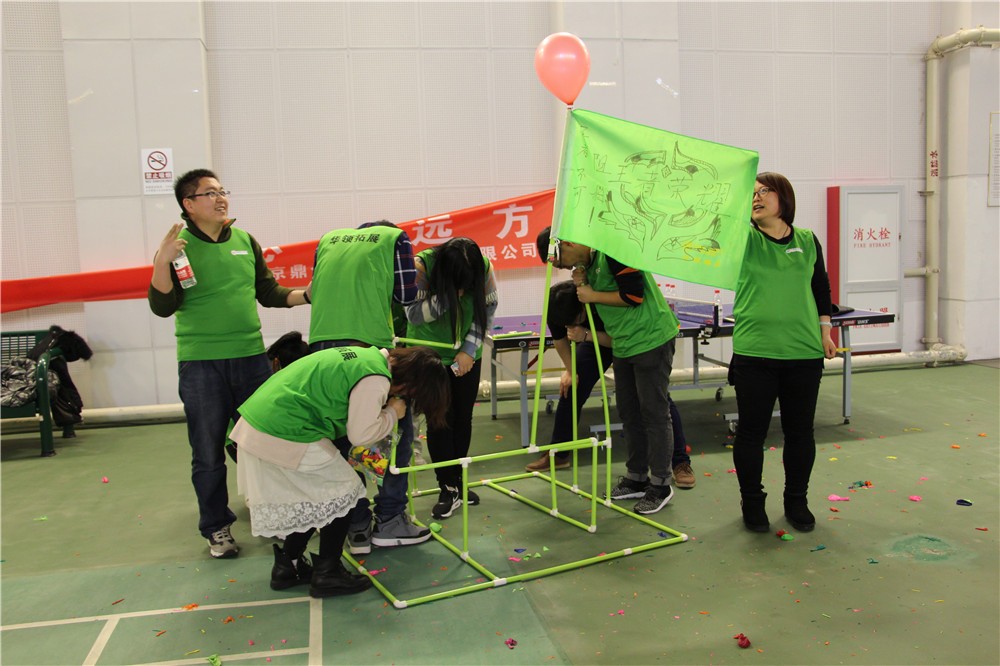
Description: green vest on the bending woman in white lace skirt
xmin=239 ymin=347 xmax=391 ymax=443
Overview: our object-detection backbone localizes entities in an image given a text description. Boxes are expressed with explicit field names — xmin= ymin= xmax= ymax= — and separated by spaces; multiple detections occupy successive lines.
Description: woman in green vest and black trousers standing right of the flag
xmin=729 ymin=172 xmax=836 ymax=532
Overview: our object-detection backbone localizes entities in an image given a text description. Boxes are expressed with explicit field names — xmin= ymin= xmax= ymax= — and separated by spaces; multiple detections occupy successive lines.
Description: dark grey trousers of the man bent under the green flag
xmin=615 ymin=340 xmax=674 ymax=486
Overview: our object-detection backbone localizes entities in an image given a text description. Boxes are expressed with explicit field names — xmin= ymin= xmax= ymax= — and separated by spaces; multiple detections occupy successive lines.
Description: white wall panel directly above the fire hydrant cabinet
xmin=834 ymin=55 xmax=890 ymax=179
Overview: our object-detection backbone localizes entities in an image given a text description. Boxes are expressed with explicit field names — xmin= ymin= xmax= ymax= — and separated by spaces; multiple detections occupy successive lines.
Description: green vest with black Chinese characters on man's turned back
xmin=309 ymin=227 xmax=403 ymax=348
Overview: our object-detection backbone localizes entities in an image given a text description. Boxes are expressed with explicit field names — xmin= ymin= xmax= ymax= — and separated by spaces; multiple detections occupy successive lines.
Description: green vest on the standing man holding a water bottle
xmin=174 ymin=228 xmax=264 ymax=361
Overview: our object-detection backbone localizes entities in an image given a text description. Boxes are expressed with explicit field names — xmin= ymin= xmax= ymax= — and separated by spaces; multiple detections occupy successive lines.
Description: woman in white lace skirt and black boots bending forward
xmin=231 ymin=347 xmax=450 ymax=597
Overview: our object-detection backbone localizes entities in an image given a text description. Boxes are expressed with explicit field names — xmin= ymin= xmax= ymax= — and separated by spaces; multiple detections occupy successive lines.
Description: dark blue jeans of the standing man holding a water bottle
xmin=177 ymin=354 xmax=271 ymax=538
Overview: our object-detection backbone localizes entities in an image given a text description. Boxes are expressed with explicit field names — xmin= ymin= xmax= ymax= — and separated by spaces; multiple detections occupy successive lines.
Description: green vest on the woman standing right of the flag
xmin=733 ymin=227 xmax=823 ymax=360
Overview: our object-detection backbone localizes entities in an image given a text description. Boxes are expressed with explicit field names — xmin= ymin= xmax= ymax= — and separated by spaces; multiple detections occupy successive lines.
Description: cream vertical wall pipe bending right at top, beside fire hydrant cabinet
xmin=916 ymin=26 xmax=1000 ymax=349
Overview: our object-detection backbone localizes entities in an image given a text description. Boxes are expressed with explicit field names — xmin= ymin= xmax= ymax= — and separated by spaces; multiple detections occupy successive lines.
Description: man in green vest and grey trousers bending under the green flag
xmin=538 ymin=228 xmax=680 ymax=514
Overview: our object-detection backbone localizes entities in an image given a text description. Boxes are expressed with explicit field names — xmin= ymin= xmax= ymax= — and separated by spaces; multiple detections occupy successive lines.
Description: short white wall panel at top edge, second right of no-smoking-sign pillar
xmin=274 ymin=2 xmax=348 ymax=49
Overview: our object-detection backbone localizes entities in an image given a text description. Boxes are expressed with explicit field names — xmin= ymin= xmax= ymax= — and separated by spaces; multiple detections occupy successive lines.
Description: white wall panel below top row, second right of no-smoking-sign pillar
xmin=273 ymin=51 xmax=354 ymax=192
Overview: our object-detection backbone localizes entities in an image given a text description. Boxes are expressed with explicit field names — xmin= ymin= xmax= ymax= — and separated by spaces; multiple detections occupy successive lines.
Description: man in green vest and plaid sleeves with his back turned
xmin=308 ymin=220 xmax=431 ymax=555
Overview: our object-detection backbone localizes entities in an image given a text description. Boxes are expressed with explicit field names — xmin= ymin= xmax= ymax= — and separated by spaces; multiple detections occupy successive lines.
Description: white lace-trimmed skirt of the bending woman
xmin=236 ymin=444 xmax=365 ymax=539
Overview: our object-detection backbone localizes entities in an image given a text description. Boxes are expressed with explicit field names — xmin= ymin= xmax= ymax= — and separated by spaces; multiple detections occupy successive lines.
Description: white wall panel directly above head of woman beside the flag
xmin=716 ymin=53 xmax=778 ymax=158
